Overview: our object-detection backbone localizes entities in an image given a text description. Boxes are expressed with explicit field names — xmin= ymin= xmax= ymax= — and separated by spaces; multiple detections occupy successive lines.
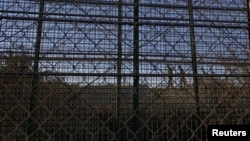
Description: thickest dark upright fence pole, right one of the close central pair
xmin=133 ymin=0 xmax=140 ymax=140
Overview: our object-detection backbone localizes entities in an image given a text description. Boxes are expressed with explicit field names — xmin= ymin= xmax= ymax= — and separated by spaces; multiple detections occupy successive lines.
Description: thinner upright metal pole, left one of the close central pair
xmin=116 ymin=0 xmax=122 ymax=139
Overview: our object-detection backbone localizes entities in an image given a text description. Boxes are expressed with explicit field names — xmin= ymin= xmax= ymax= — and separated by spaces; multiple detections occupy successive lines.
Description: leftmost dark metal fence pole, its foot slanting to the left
xmin=27 ymin=0 xmax=44 ymax=135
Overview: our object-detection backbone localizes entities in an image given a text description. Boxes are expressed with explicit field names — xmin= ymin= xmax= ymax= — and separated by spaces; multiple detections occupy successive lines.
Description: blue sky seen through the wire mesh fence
xmin=0 ymin=0 xmax=250 ymax=87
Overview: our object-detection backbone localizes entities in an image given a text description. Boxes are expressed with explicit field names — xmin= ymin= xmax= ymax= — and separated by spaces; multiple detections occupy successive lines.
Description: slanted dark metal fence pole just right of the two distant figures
xmin=188 ymin=0 xmax=200 ymax=137
